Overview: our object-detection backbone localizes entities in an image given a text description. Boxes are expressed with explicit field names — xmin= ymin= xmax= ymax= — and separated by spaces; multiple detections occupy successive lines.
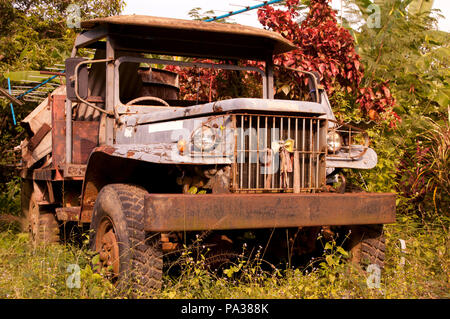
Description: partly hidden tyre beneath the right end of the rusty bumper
xmin=348 ymin=225 xmax=386 ymax=268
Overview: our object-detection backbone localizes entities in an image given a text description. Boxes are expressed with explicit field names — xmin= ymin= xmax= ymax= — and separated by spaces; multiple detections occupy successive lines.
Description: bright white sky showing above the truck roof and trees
xmin=122 ymin=0 xmax=450 ymax=32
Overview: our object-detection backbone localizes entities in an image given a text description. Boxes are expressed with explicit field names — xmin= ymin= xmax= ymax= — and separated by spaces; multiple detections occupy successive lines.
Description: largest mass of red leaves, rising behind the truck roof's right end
xmin=258 ymin=0 xmax=363 ymax=94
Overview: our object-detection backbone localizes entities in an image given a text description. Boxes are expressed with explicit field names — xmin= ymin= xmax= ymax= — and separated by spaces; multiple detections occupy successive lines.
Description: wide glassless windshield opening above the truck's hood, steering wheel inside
xmin=115 ymin=56 xmax=267 ymax=106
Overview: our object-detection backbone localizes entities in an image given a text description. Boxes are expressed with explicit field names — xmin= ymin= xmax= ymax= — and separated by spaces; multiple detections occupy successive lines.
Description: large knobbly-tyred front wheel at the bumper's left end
xmin=90 ymin=184 xmax=163 ymax=295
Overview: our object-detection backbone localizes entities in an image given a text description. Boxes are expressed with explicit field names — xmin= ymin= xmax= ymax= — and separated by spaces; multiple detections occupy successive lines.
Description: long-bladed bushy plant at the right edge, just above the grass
xmin=397 ymin=115 xmax=450 ymax=217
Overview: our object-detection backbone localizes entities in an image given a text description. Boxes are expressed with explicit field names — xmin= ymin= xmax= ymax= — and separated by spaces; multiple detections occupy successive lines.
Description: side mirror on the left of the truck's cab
xmin=66 ymin=58 xmax=88 ymax=101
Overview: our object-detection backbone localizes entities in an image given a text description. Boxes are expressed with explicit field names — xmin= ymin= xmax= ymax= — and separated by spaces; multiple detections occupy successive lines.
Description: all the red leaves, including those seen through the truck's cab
xmin=171 ymin=0 xmax=398 ymax=124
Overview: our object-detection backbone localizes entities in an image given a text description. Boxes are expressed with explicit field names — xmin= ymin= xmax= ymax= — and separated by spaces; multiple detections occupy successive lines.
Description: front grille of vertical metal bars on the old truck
xmin=231 ymin=114 xmax=327 ymax=192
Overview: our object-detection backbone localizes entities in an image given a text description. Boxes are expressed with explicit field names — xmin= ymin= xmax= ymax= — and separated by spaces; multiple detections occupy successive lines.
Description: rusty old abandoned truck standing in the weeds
xmin=21 ymin=15 xmax=395 ymax=291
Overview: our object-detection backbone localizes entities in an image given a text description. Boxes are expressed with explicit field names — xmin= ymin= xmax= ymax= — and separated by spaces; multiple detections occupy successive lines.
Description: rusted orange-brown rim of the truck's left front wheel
xmin=95 ymin=217 xmax=119 ymax=280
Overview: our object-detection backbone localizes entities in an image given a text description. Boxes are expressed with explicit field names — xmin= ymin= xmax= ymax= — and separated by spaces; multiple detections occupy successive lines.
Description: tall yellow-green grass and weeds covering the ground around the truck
xmin=0 ymin=217 xmax=450 ymax=299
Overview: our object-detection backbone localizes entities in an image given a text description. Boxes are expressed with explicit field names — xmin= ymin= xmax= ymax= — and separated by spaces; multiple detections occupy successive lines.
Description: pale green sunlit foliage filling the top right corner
xmin=356 ymin=0 xmax=450 ymax=116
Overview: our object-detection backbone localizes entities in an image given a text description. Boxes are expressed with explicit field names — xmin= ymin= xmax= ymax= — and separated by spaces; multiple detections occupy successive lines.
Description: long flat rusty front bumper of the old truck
xmin=145 ymin=193 xmax=395 ymax=232
